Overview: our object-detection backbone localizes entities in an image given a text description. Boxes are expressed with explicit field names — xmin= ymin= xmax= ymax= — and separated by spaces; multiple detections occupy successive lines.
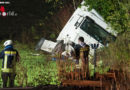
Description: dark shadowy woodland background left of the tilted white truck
xmin=0 ymin=0 xmax=81 ymax=43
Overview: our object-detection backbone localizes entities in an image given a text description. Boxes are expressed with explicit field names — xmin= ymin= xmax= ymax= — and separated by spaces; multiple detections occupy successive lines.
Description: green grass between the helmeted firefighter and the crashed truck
xmin=0 ymin=43 xmax=60 ymax=87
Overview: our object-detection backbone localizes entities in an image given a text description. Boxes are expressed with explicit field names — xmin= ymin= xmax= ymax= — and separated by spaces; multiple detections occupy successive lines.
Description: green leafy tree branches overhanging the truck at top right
xmin=85 ymin=0 xmax=130 ymax=33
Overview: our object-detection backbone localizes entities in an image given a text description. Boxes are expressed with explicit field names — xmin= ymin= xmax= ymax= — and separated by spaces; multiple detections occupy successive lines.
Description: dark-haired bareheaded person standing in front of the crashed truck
xmin=74 ymin=37 xmax=90 ymax=73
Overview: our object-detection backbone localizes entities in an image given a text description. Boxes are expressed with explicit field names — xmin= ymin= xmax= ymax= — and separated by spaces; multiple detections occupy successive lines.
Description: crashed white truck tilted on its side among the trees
xmin=36 ymin=2 xmax=117 ymax=55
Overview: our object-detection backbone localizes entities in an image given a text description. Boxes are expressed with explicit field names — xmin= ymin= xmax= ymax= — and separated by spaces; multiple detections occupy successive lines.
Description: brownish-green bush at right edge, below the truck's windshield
xmin=99 ymin=32 xmax=130 ymax=71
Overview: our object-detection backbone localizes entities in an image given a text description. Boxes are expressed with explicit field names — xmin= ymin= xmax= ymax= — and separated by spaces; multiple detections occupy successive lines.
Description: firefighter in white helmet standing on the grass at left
xmin=0 ymin=40 xmax=20 ymax=88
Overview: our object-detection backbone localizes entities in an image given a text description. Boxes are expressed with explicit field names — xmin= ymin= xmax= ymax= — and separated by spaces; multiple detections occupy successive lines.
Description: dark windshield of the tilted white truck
xmin=80 ymin=18 xmax=116 ymax=45
